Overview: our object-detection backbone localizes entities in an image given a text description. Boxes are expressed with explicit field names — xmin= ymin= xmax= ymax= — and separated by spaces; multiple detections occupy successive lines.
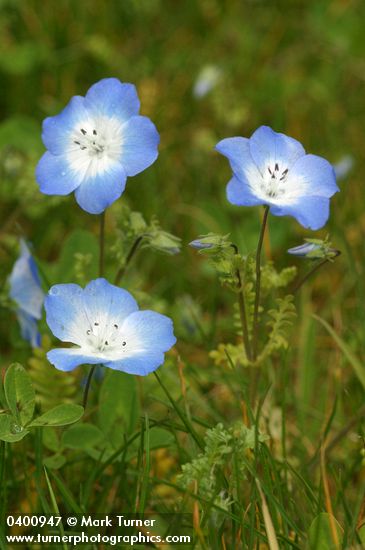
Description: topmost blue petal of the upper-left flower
xmin=85 ymin=78 xmax=140 ymax=121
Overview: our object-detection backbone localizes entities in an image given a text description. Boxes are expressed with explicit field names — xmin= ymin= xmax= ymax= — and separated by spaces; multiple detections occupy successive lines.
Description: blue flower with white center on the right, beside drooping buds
xmin=216 ymin=126 xmax=339 ymax=229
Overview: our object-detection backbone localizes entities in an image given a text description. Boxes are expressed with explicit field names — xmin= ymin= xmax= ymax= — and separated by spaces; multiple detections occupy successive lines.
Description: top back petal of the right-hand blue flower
xmin=249 ymin=126 xmax=305 ymax=174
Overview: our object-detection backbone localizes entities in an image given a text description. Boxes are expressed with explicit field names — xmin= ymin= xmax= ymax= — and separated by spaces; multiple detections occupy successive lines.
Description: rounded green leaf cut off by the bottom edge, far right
xmin=307 ymin=512 xmax=342 ymax=550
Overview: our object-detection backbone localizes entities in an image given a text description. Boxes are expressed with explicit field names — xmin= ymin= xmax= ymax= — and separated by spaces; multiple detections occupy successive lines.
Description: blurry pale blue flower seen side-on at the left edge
xmin=9 ymin=239 xmax=44 ymax=347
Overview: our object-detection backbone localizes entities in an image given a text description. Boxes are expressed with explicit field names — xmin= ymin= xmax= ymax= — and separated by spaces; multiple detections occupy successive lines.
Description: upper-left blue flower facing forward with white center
xmin=36 ymin=78 xmax=160 ymax=214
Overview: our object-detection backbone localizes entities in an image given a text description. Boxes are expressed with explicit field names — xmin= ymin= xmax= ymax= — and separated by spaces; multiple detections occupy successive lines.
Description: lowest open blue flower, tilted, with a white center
xmin=45 ymin=279 xmax=176 ymax=376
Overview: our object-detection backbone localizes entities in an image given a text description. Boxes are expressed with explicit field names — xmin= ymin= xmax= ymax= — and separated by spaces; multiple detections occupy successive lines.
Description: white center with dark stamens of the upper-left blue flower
xmin=67 ymin=116 xmax=123 ymax=178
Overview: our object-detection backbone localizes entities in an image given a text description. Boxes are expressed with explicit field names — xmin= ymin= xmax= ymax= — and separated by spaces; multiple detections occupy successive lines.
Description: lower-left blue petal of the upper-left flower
xmin=35 ymin=151 xmax=82 ymax=195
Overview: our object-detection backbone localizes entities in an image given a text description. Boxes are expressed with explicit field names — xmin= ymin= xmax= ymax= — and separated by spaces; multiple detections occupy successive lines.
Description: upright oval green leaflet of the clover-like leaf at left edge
xmin=4 ymin=363 xmax=35 ymax=426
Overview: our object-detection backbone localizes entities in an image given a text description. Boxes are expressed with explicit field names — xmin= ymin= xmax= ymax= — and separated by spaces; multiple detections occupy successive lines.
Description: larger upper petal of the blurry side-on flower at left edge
xmin=9 ymin=240 xmax=44 ymax=319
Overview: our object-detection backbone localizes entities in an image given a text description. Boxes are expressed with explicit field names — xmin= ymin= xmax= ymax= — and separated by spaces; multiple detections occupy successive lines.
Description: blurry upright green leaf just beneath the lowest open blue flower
xmin=98 ymin=371 xmax=140 ymax=445
